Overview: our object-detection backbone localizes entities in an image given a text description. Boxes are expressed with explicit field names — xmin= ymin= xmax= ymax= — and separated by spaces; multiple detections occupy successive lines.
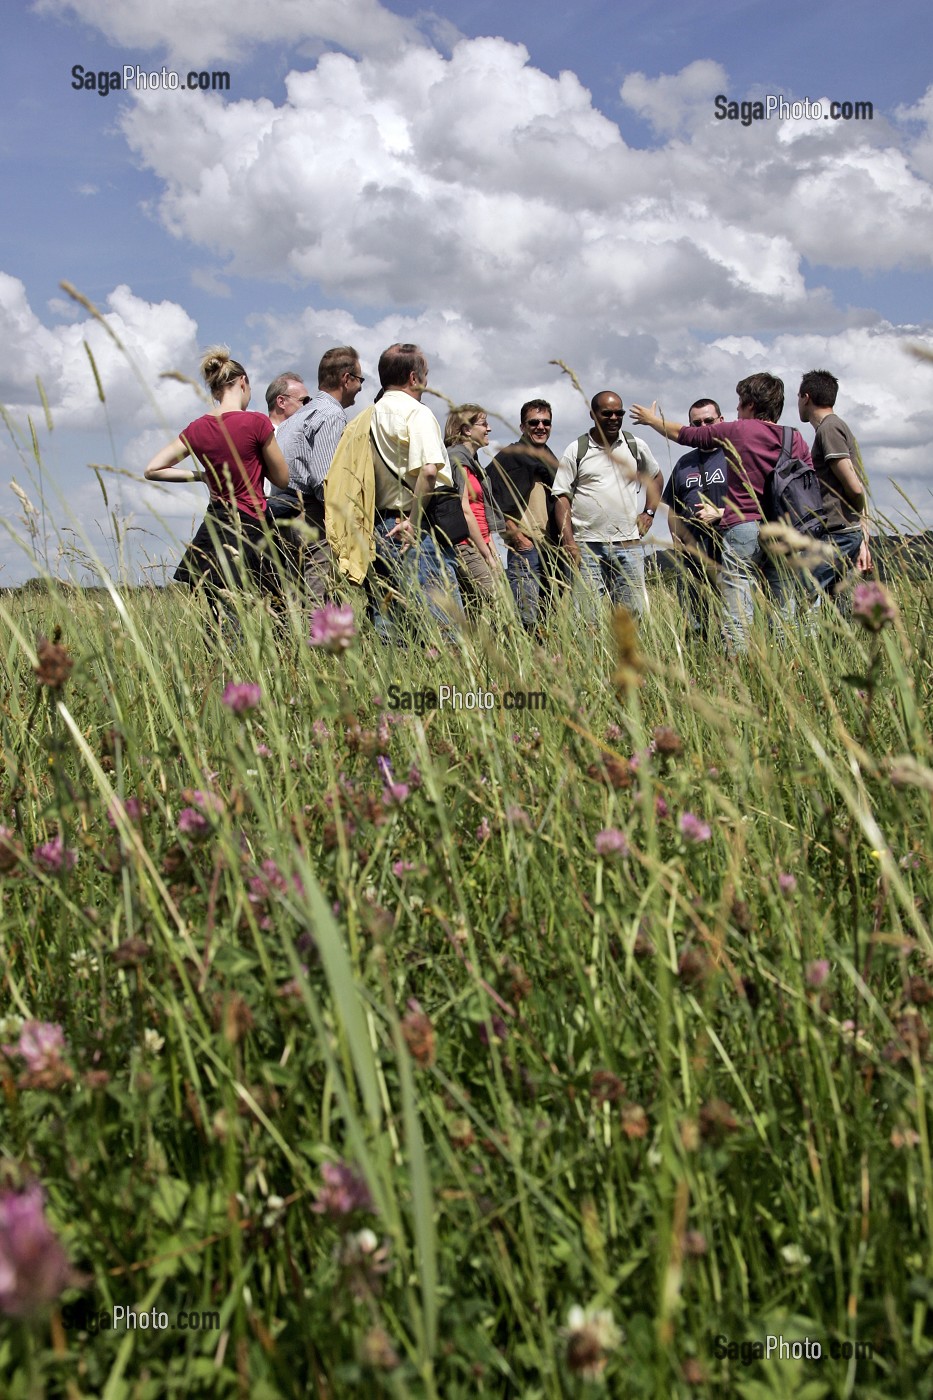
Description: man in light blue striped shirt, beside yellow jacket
xmin=269 ymin=346 xmax=366 ymax=603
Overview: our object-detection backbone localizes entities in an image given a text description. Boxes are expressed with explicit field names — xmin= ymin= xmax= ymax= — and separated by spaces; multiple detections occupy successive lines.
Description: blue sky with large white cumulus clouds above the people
xmin=0 ymin=0 xmax=933 ymax=584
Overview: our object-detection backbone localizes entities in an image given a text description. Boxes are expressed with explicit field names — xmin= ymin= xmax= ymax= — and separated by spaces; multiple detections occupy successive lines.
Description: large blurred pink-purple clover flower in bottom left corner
xmin=0 ymin=1182 xmax=71 ymax=1317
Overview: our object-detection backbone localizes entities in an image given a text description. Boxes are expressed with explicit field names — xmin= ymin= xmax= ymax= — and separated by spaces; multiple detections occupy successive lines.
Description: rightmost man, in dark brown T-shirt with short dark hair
xmin=797 ymin=370 xmax=871 ymax=606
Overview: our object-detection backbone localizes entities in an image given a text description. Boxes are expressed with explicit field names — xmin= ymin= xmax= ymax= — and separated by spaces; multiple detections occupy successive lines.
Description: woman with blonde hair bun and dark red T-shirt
xmin=146 ymin=346 xmax=289 ymax=604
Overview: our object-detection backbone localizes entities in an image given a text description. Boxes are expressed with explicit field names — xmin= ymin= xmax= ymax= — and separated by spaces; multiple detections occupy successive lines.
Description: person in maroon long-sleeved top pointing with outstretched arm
xmin=630 ymin=374 xmax=810 ymax=652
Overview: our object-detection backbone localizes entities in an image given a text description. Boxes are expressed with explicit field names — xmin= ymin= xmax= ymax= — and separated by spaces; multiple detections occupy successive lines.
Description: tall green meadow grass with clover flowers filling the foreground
xmin=0 ymin=537 xmax=933 ymax=1400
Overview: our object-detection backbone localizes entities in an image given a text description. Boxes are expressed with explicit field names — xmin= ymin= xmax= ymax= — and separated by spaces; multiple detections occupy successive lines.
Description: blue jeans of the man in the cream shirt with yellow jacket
xmin=367 ymin=515 xmax=464 ymax=645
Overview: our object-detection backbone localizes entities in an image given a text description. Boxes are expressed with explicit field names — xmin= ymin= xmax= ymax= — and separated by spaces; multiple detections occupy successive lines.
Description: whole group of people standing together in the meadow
xmin=146 ymin=343 xmax=871 ymax=650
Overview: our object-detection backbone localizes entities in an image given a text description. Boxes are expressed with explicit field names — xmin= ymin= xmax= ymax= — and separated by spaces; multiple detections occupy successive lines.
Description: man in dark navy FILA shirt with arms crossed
xmin=661 ymin=399 xmax=726 ymax=637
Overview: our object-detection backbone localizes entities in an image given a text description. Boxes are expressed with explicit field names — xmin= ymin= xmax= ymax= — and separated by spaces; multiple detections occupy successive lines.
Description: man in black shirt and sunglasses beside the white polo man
xmin=489 ymin=399 xmax=558 ymax=631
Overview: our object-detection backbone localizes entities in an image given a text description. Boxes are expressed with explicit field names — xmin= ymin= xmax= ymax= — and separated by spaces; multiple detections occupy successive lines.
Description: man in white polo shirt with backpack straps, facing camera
xmin=552 ymin=389 xmax=664 ymax=617
